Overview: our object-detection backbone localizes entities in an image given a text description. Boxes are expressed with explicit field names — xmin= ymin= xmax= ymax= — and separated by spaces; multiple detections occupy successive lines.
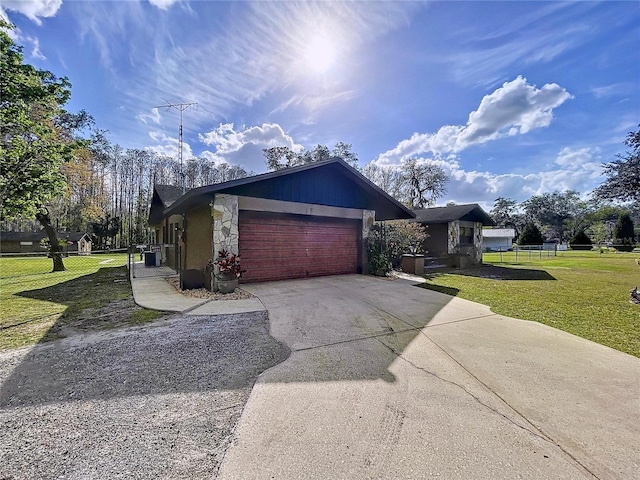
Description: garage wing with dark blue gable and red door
xmin=149 ymin=158 xmax=414 ymax=282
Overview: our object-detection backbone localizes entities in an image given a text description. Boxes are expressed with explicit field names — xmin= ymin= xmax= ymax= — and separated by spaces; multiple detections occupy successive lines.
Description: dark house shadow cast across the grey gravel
xmin=0 ymin=312 xmax=289 ymax=408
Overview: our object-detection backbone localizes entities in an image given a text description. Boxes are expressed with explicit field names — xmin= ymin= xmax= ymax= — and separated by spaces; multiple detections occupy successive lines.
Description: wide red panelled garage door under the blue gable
xmin=239 ymin=211 xmax=360 ymax=282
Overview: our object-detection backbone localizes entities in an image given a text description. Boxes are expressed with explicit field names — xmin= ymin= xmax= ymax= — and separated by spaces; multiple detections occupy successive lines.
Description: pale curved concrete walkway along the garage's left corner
xmin=131 ymin=277 xmax=265 ymax=315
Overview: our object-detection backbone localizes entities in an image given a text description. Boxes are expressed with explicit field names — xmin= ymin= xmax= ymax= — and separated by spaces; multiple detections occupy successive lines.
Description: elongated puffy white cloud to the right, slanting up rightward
xmin=376 ymin=76 xmax=571 ymax=165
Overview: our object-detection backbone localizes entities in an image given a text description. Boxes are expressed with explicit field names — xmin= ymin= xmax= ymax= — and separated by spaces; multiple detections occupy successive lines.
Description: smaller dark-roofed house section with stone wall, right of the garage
xmin=410 ymin=203 xmax=495 ymax=268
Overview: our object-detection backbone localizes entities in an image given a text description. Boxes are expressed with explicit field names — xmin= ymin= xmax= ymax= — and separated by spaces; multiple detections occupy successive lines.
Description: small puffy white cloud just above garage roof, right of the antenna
xmin=198 ymin=123 xmax=303 ymax=172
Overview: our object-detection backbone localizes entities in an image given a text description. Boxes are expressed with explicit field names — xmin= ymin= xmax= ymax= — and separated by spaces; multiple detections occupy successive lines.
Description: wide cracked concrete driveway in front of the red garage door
xmin=219 ymin=275 xmax=640 ymax=479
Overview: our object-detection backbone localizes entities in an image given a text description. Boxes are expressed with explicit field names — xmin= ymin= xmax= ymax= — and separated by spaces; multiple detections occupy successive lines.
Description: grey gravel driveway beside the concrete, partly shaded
xmin=0 ymin=312 xmax=289 ymax=479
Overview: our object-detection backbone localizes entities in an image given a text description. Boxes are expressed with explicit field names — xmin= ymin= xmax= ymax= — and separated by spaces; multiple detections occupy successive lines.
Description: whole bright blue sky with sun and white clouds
xmin=0 ymin=0 xmax=640 ymax=208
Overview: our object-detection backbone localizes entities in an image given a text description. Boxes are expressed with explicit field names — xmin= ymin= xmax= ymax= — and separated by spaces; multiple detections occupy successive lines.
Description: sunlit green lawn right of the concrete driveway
xmin=423 ymin=252 xmax=640 ymax=357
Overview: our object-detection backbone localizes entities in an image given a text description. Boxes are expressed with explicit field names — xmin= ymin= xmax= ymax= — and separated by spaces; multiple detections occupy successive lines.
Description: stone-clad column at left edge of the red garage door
xmin=211 ymin=193 xmax=239 ymax=291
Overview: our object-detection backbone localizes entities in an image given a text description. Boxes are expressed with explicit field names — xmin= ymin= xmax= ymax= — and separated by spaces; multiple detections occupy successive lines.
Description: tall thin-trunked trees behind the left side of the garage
xmin=0 ymin=131 xmax=249 ymax=250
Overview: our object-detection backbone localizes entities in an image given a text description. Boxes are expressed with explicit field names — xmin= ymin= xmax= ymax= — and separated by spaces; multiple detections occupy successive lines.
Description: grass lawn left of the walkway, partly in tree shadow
xmin=0 ymin=253 xmax=164 ymax=350
